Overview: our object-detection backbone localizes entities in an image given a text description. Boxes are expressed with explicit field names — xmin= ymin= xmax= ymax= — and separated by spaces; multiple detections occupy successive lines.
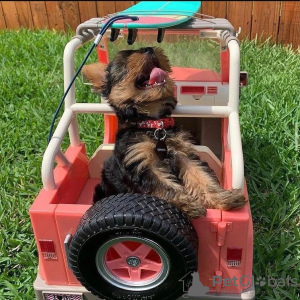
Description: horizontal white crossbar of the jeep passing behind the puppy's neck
xmin=71 ymin=103 xmax=231 ymax=117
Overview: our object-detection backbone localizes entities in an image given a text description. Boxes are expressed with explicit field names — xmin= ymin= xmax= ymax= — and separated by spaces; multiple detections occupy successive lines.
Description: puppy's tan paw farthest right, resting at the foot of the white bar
xmin=215 ymin=189 xmax=248 ymax=210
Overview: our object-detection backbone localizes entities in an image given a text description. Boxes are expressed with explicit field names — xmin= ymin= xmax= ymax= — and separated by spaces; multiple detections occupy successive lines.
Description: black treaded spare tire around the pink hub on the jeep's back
xmin=69 ymin=194 xmax=198 ymax=300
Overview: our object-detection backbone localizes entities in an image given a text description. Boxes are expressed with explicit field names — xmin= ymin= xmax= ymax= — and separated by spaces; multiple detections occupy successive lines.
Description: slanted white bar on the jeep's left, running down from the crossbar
xmin=42 ymin=109 xmax=74 ymax=191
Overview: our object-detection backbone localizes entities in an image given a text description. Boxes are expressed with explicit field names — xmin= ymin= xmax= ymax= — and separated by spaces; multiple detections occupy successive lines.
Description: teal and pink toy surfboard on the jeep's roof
xmin=103 ymin=1 xmax=201 ymax=29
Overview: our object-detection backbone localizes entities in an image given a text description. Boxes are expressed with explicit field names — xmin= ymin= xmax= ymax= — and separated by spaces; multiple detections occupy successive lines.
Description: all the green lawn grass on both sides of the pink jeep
xmin=0 ymin=30 xmax=300 ymax=300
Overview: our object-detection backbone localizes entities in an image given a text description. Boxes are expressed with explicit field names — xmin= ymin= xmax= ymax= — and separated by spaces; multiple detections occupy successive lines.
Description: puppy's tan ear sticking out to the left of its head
xmin=81 ymin=62 xmax=107 ymax=93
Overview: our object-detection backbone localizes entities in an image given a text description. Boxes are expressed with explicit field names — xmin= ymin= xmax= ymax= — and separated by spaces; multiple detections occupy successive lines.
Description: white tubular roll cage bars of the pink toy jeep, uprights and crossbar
xmin=42 ymin=32 xmax=244 ymax=190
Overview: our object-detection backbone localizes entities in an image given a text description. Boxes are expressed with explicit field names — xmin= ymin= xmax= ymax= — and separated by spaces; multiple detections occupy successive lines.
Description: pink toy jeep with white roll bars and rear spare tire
xmin=30 ymin=11 xmax=255 ymax=300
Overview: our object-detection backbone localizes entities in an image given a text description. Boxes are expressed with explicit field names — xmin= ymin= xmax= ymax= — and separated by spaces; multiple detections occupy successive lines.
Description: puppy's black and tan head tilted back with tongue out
xmin=82 ymin=47 xmax=177 ymax=122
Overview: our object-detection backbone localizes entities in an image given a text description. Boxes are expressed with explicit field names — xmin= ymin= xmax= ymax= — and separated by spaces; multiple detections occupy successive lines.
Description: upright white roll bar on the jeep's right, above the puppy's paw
xmin=228 ymin=40 xmax=244 ymax=189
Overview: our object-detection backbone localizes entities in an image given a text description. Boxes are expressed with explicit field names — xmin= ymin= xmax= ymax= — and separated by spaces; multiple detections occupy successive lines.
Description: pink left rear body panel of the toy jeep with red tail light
xmin=29 ymin=144 xmax=91 ymax=285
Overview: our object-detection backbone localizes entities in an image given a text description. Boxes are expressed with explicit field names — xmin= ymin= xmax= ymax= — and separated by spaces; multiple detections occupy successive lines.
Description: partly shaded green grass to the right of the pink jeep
xmin=240 ymin=38 xmax=300 ymax=299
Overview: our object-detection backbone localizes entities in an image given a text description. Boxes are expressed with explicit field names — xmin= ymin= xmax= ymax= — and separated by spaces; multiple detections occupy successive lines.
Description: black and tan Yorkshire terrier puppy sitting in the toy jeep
xmin=82 ymin=47 xmax=246 ymax=218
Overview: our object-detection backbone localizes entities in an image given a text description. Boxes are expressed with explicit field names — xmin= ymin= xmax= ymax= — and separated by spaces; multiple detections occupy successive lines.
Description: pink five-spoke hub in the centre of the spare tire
xmin=104 ymin=241 xmax=163 ymax=283
